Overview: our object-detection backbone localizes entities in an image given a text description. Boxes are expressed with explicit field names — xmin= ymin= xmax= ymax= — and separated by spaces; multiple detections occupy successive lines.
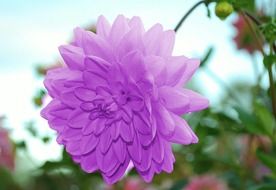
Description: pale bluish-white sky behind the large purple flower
xmin=0 ymin=0 xmax=261 ymax=163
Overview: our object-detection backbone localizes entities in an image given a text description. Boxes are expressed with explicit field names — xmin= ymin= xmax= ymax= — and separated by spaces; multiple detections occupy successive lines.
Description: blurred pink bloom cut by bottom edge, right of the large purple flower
xmin=184 ymin=175 xmax=228 ymax=190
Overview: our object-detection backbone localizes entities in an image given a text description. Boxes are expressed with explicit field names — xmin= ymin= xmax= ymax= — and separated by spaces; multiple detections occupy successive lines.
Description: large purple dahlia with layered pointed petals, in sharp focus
xmin=41 ymin=16 xmax=208 ymax=184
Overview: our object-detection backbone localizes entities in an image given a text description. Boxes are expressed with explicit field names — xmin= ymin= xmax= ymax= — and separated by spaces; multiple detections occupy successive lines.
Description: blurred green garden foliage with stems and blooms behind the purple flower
xmin=0 ymin=0 xmax=276 ymax=190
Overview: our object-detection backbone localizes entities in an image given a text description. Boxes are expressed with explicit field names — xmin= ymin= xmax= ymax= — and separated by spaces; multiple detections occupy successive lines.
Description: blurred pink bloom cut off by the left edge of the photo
xmin=0 ymin=118 xmax=14 ymax=170
